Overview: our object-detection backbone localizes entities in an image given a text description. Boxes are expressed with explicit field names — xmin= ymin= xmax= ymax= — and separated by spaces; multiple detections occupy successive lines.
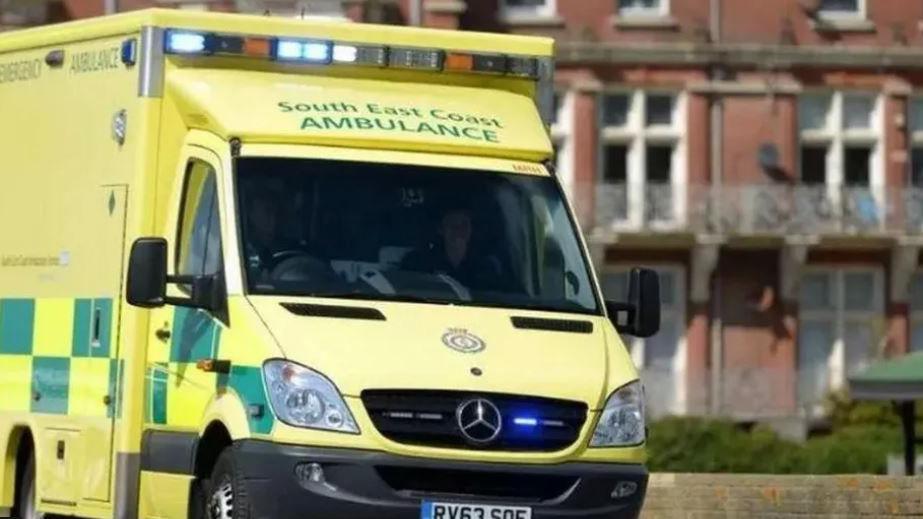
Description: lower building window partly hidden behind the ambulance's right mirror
xmin=602 ymin=265 xmax=687 ymax=416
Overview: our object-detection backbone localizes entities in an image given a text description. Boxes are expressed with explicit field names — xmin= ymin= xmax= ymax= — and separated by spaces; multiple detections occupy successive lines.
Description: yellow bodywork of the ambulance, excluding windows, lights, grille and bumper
xmin=0 ymin=10 xmax=644 ymax=519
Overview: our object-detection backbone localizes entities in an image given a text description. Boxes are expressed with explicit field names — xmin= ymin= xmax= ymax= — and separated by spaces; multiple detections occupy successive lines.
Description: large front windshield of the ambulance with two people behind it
xmin=236 ymin=157 xmax=599 ymax=313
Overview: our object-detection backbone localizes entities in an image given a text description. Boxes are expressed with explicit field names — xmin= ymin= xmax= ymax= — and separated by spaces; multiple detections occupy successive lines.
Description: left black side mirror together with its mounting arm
xmin=125 ymin=238 xmax=225 ymax=311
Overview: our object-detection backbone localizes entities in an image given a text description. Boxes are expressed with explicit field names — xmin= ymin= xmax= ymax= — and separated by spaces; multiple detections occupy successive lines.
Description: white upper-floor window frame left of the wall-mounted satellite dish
xmin=597 ymin=88 xmax=687 ymax=231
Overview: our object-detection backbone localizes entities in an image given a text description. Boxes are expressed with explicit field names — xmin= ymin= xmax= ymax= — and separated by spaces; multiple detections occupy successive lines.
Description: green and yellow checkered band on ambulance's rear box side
xmin=0 ymin=298 xmax=121 ymax=418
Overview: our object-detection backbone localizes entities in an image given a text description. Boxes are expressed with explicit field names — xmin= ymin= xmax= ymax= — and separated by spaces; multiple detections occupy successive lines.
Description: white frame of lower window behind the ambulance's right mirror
xmin=602 ymin=263 xmax=688 ymax=414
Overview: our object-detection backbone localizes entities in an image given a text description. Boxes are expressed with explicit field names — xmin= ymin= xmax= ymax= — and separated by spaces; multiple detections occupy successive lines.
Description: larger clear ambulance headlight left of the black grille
xmin=263 ymin=360 xmax=359 ymax=434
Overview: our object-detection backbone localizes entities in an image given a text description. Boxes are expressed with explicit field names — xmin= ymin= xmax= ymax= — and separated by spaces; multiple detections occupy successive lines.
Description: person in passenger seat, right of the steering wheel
xmin=402 ymin=206 xmax=501 ymax=290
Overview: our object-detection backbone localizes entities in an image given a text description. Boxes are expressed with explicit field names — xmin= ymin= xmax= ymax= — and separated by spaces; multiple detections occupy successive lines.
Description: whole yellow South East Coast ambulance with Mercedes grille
xmin=0 ymin=10 xmax=660 ymax=519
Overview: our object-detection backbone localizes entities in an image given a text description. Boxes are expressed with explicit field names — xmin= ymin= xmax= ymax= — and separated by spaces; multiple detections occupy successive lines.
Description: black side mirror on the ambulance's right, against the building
xmin=606 ymin=268 xmax=660 ymax=338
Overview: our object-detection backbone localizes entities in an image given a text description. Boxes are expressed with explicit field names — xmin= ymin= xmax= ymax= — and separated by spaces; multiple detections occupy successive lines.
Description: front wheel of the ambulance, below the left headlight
xmin=201 ymin=446 xmax=254 ymax=519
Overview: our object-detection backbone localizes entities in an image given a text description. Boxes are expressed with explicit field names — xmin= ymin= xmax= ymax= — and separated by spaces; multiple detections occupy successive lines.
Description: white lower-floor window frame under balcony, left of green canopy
xmin=795 ymin=264 xmax=885 ymax=416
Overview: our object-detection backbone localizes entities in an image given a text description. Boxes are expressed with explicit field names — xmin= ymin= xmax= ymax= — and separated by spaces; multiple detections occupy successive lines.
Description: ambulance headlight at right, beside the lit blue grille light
xmin=590 ymin=380 xmax=645 ymax=447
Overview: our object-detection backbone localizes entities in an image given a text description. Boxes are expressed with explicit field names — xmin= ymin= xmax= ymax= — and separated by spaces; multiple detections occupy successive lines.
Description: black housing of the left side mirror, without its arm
xmin=125 ymin=238 xmax=167 ymax=308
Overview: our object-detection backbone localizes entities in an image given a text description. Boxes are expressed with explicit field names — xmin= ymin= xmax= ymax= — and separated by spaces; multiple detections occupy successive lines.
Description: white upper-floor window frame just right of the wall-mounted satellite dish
xmin=798 ymin=90 xmax=886 ymax=227
